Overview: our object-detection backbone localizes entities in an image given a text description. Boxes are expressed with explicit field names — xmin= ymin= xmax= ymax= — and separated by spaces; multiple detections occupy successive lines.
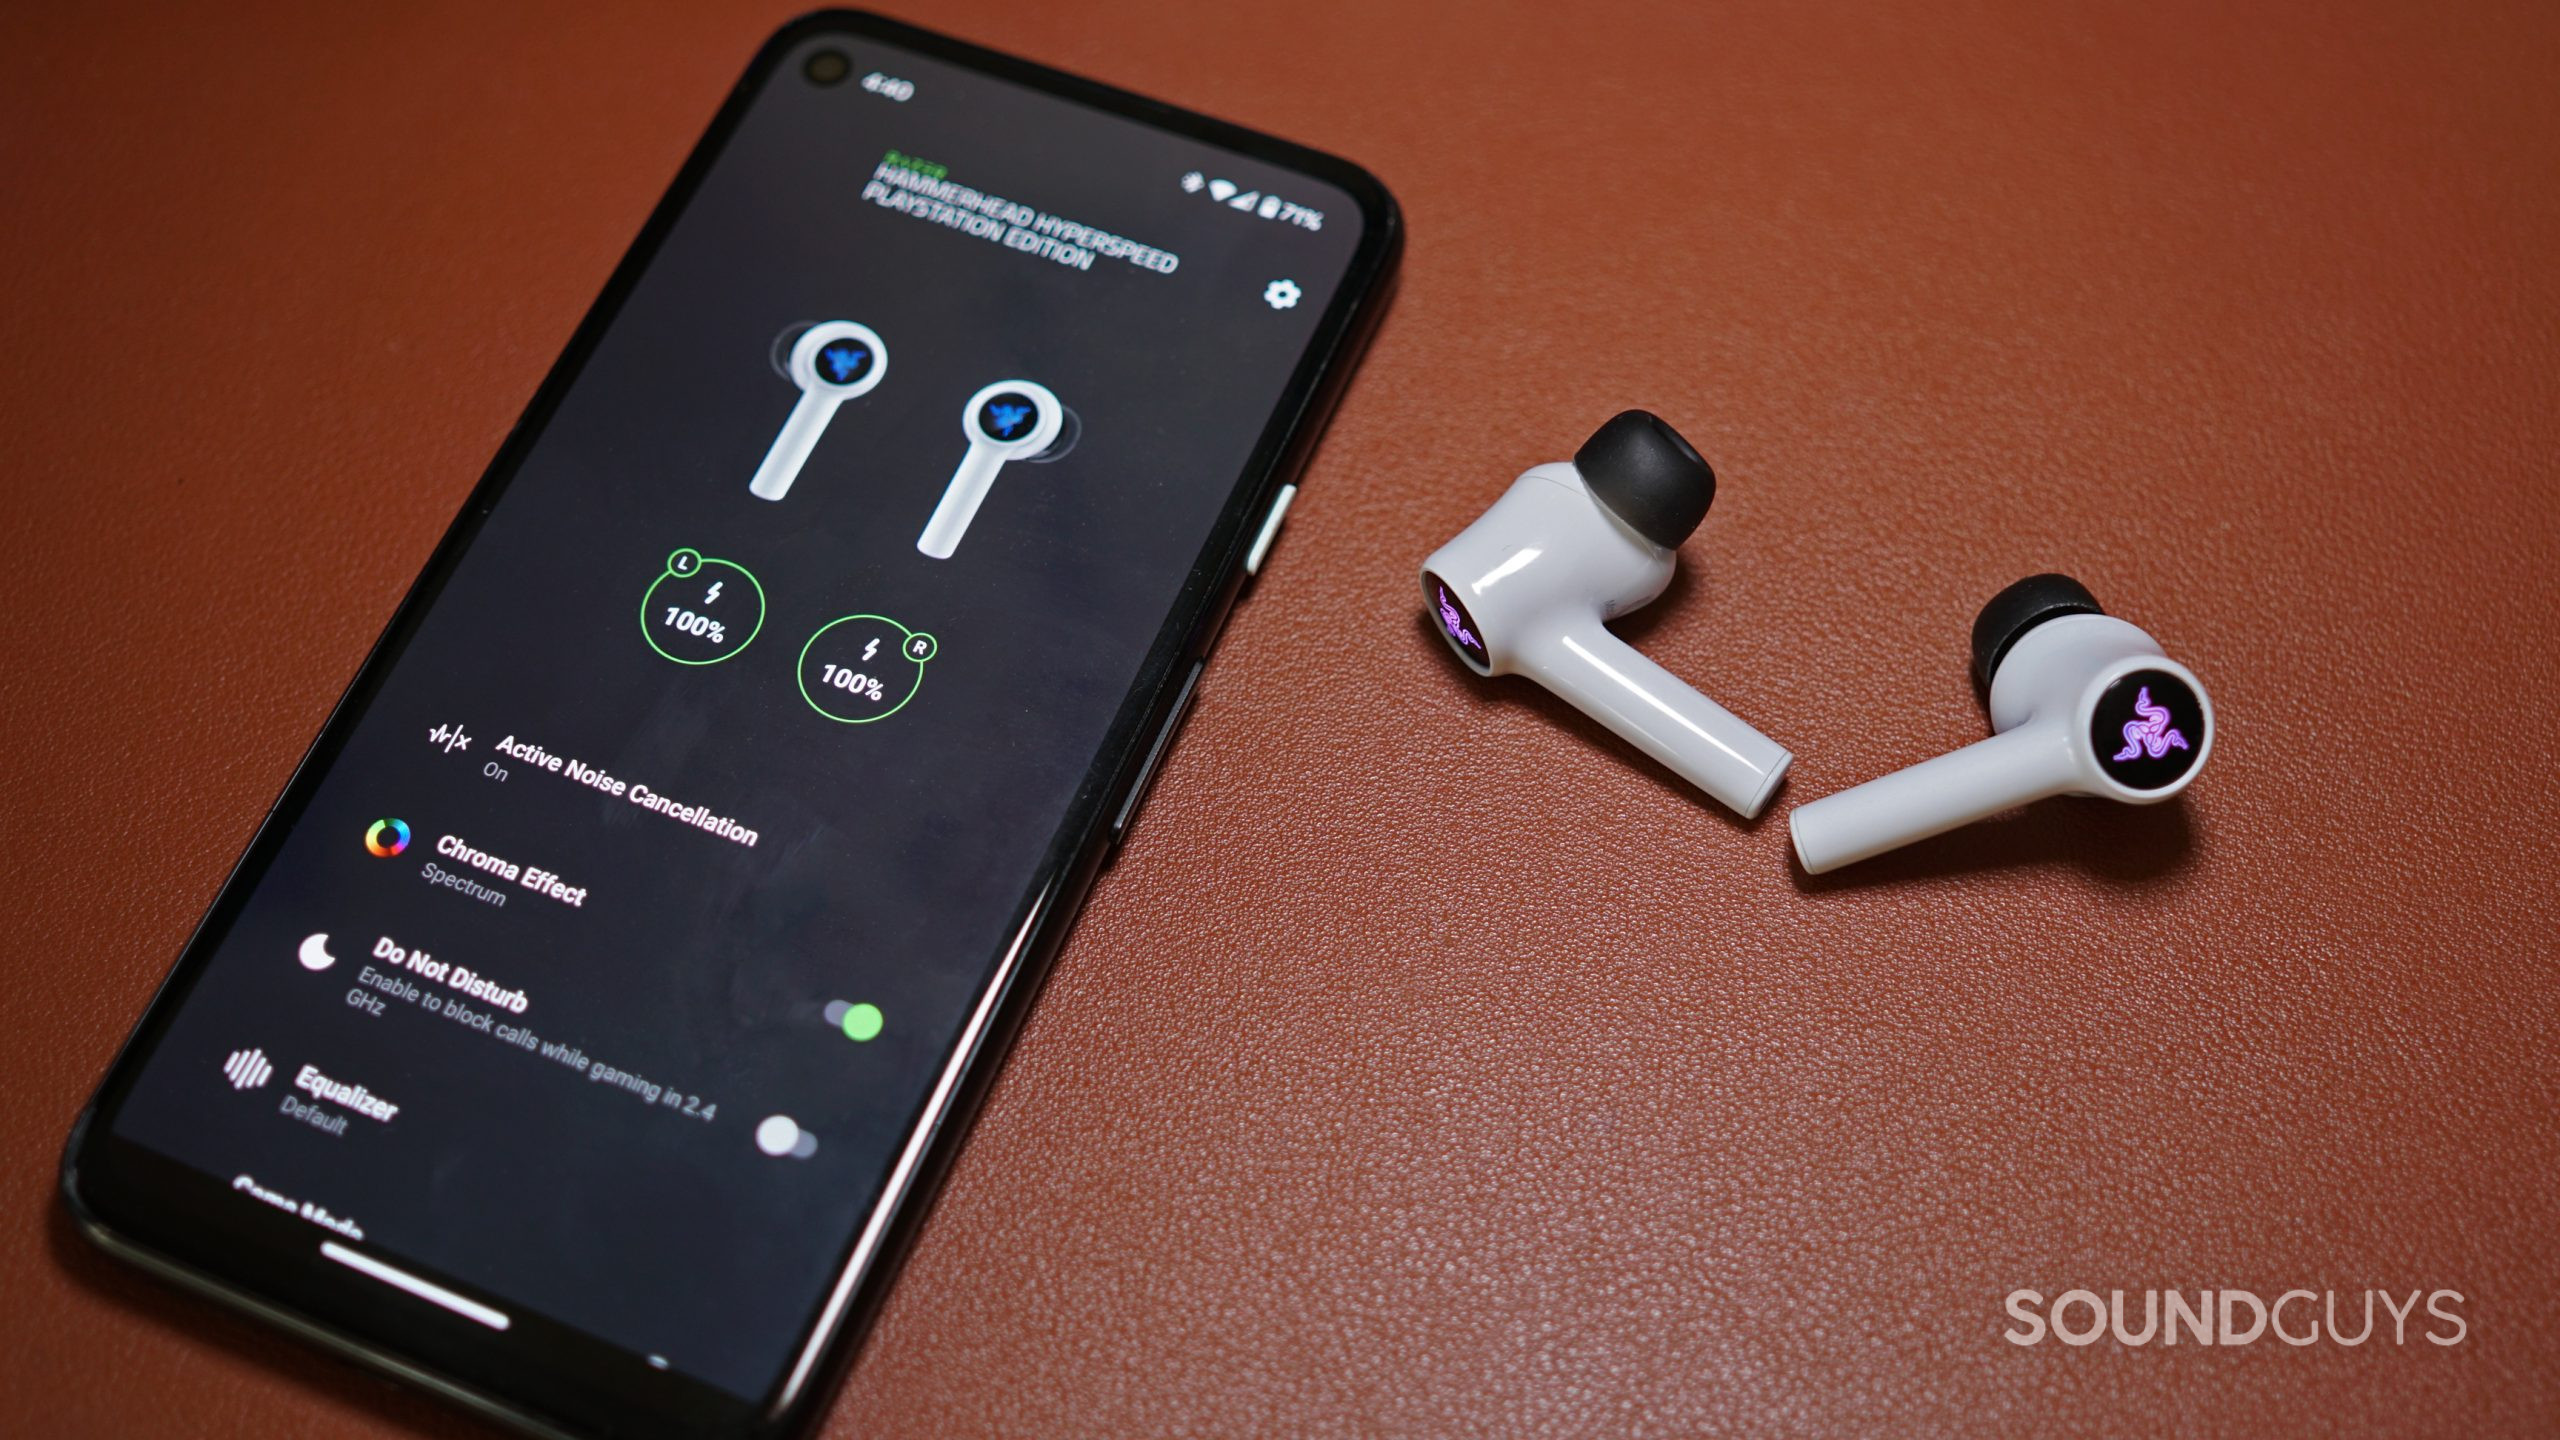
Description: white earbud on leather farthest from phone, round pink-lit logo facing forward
xmin=1789 ymin=574 xmax=2214 ymax=874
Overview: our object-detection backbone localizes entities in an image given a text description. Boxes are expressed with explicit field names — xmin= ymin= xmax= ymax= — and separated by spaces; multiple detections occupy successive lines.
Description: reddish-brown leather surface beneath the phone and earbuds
xmin=0 ymin=0 xmax=2560 ymax=1437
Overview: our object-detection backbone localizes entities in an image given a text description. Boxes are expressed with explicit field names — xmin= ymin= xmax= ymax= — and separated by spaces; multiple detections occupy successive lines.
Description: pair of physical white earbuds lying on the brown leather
xmin=1423 ymin=410 xmax=2214 ymax=874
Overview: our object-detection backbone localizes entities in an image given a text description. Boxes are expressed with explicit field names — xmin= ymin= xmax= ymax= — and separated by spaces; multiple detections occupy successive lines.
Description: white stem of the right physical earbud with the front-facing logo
xmin=1787 ymin=717 xmax=2081 ymax=874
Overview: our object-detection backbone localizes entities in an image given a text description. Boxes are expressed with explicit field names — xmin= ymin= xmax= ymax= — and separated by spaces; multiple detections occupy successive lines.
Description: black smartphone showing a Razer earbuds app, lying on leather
xmin=61 ymin=13 xmax=1400 ymax=1435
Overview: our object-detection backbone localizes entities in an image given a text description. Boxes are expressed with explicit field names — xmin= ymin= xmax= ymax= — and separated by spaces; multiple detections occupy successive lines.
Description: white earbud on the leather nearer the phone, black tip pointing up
xmin=1423 ymin=410 xmax=1792 ymax=817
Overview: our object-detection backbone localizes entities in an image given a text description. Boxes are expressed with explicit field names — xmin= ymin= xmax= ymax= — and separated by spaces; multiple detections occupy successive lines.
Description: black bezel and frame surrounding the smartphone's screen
xmin=61 ymin=10 xmax=1403 ymax=1437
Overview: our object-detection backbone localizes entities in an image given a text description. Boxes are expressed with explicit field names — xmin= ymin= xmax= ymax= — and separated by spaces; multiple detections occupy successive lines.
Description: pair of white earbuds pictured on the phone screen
xmin=748 ymin=320 xmax=1075 ymax=561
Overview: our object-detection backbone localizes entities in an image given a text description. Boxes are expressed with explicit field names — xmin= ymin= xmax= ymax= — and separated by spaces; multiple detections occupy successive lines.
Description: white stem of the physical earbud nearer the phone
xmin=1513 ymin=623 xmax=1795 ymax=820
